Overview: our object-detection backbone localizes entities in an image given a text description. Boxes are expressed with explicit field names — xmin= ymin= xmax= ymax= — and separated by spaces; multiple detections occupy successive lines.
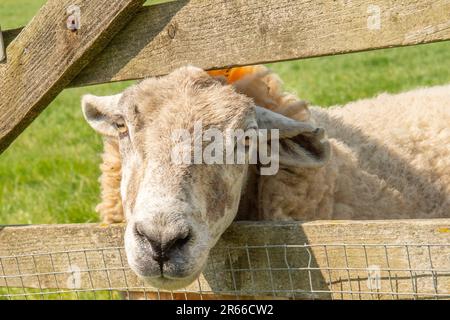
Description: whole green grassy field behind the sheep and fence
xmin=0 ymin=0 xmax=450 ymax=224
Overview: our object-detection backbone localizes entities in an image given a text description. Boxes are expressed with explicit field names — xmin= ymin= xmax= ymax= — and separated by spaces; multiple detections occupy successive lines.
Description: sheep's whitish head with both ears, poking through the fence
xmin=82 ymin=67 xmax=328 ymax=289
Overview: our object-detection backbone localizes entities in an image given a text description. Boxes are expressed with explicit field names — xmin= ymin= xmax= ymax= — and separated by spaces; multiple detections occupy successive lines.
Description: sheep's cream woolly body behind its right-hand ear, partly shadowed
xmin=260 ymin=85 xmax=450 ymax=220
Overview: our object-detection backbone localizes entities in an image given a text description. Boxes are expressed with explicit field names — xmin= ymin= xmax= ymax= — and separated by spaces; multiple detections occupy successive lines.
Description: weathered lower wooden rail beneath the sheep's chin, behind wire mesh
xmin=0 ymin=219 xmax=450 ymax=299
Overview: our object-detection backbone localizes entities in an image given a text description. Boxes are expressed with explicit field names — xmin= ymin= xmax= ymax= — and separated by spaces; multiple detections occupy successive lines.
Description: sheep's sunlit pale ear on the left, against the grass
xmin=81 ymin=93 xmax=122 ymax=137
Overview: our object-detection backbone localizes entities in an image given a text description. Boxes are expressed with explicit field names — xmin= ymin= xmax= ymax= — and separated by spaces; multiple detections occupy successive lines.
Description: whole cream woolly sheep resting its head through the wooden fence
xmin=82 ymin=66 xmax=450 ymax=289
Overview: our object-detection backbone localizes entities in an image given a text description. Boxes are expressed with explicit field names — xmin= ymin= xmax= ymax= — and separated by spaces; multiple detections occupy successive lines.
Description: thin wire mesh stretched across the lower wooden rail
xmin=0 ymin=244 xmax=450 ymax=299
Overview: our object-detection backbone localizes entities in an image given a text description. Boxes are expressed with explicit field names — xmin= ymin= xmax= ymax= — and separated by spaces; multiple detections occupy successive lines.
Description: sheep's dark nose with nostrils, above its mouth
xmin=136 ymin=224 xmax=191 ymax=268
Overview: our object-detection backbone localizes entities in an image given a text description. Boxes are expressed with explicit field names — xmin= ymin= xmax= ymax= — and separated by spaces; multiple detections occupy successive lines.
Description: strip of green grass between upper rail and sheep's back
xmin=270 ymin=42 xmax=450 ymax=106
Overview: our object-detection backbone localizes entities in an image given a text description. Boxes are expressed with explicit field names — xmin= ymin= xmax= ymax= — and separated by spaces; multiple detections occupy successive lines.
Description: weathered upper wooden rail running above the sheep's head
xmin=67 ymin=0 xmax=450 ymax=86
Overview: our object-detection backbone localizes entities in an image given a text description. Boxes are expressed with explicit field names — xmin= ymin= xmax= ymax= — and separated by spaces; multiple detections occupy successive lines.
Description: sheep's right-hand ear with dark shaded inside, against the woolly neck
xmin=256 ymin=107 xmax=330 ymax=168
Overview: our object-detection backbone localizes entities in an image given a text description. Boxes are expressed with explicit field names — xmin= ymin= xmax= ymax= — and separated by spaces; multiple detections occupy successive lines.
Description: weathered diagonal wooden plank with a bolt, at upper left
xmin=0 ymin=0 xmax=144 ymax=152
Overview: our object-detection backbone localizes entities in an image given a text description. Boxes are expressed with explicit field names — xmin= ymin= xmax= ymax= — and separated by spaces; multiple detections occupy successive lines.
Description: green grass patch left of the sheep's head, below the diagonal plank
xmin=0 ymin=83 xmax=134 ymax=224
